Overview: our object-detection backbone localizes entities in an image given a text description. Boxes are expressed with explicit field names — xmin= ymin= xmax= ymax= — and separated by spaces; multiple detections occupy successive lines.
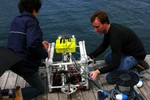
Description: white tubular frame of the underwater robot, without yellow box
xmin=45 ymin=41 xmax=89 ymax=92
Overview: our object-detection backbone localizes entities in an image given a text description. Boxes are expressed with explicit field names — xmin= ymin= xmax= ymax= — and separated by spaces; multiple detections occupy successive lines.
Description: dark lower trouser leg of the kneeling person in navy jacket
xmin=22 ymin=72 xmax=45 ymax=100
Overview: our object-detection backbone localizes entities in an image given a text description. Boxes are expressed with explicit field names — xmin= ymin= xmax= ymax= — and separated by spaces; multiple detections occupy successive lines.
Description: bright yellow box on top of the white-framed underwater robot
xmin=55 ymin=37 xmax=76 ymax=53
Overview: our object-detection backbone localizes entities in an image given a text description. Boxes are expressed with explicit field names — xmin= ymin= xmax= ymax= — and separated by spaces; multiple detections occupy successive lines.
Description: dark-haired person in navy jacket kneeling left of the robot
xmin=7 ymin=0 xmax=48 ymax=100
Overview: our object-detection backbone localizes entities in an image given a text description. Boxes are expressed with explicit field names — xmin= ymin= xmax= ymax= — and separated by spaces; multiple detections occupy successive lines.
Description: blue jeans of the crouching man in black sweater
xmin=104 ymin=52 xmax=138 ymax=84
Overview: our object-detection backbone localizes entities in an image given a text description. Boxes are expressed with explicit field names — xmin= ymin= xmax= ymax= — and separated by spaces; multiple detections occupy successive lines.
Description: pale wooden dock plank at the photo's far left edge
xmin=0 ymin=71 xmax=10 ymax=89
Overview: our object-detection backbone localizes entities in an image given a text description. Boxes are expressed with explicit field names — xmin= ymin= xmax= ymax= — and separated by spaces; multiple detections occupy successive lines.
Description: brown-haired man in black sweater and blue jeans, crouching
xmin=89 ymin=11 xmax=146 ymax=83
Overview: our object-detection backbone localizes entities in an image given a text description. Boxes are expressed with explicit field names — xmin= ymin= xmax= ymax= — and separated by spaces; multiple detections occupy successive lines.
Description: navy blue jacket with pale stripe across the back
xmin=7 ymin=11 xmax=47 ymax=62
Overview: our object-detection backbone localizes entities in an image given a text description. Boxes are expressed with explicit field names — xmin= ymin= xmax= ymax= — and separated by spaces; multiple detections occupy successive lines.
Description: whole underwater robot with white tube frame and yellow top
xmin=45 ymin=35 xmax=89 ymax=94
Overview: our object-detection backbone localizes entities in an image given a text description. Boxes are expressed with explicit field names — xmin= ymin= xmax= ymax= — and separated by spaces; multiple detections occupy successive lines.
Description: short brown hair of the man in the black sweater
xmin=91 ymin=10 xmax=109 ymax=24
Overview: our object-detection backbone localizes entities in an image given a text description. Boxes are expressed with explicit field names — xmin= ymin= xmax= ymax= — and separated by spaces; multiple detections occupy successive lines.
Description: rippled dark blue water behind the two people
xmin=0 ymin=0 xmax=150 ymax=58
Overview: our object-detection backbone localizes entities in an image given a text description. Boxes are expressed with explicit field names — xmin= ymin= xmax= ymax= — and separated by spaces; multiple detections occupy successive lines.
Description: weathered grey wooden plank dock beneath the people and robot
xmin=0 ymin=55 xmax=150 ymax=100
